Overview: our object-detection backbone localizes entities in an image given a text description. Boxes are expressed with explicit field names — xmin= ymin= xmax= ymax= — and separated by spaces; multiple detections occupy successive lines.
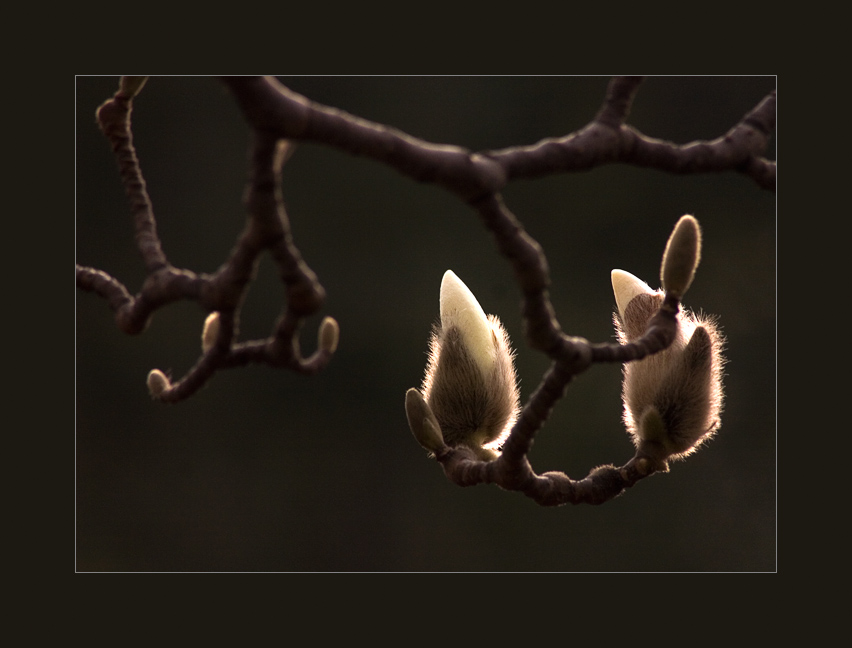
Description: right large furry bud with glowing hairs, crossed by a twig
xmin=612 ymin=270 xmax=724 ymax=470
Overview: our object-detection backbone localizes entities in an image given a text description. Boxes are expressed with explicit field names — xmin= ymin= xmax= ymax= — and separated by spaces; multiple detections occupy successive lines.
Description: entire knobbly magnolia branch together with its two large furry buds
xmin=81 ymin=77 xmax=776 ymax=505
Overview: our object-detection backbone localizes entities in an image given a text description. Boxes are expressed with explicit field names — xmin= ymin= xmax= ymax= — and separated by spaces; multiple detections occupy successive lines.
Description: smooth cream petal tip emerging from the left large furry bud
xmin=441 ymin=270 xmax=497 ymax=380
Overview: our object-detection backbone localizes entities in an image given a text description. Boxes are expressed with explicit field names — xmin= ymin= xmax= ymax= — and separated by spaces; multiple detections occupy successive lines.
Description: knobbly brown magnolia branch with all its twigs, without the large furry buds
xmin=76 ymin=77 xmax=776 ymax=505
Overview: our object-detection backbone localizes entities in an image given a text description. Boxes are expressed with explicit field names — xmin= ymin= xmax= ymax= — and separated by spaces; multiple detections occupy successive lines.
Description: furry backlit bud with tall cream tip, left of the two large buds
xmin=413 ymin=270 xmax=520 ymax=460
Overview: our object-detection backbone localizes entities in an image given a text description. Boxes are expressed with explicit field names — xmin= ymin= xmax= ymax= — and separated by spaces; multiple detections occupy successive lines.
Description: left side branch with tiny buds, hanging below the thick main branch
xmin=76 ymin=78 xmax=338 ymax=403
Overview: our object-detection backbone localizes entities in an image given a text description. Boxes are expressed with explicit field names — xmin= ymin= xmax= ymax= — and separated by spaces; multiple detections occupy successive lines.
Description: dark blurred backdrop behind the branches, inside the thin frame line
xmin=75 ymin=77 xmax=776 ymax=571
